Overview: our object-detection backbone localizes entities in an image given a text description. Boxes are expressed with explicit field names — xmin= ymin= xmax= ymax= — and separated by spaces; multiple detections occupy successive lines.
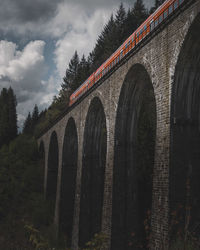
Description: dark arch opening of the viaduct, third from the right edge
xmin=79 ymin=97 xmax=107 ymax=247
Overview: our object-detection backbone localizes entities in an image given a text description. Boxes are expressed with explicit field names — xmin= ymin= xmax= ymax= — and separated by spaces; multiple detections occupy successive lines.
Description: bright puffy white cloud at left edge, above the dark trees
xmin=0 ymin=40 xmax=57 ymax=129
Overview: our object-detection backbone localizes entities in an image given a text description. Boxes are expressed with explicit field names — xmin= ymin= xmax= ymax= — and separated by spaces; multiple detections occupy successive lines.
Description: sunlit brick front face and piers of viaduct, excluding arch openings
xmin=38 ymin=0 xmax=200 ymax=250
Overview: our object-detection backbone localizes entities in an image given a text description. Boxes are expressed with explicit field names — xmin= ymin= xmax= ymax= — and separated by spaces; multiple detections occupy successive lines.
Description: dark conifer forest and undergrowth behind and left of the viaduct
xmin=0 ymin=0 xmax=170 ymax=250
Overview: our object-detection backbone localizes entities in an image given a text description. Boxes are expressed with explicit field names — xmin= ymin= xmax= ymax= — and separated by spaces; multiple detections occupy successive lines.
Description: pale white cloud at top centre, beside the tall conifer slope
xmin=51 ymin=3 xmax=111 ymax=78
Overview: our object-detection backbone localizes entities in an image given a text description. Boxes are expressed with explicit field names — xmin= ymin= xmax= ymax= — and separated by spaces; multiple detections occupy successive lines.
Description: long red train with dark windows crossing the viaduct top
xmin=69 ymin=0 xmax=186 ymax=106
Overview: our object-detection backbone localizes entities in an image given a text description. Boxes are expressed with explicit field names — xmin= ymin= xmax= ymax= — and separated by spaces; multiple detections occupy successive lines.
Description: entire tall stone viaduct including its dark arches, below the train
xmin=38 ymin=0 xmax=200 ymax=250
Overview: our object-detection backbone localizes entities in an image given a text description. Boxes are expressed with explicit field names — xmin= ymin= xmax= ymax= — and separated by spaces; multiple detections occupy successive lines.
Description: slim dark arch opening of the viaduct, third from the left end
xmin=59 ymin=117 xmax=78 ymax=247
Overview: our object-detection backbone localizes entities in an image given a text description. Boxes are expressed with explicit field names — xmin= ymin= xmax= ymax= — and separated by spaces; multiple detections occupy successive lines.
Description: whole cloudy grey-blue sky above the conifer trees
xmin=0 ymin=0 xmax=154 ymax=127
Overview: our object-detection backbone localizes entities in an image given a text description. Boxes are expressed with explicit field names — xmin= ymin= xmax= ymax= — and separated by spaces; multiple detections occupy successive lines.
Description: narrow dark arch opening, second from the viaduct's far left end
xmin=46 ymin=131 xmax=59 ymax=222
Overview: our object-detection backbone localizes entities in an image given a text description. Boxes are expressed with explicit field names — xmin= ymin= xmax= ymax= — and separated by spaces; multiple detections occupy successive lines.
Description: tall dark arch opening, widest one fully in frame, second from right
xmin=111 ymin=64 xmax=156 ymax=250
